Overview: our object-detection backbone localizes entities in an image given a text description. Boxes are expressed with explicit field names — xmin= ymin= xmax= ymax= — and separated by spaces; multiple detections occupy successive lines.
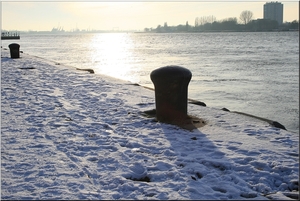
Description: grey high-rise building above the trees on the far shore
xmin=264 ymin=1 xmax=283 ymax=25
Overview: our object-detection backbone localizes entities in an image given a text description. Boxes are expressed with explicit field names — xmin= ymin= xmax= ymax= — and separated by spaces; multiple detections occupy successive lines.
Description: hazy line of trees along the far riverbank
xmin=144 ymin=10 xmax=299 ymax=33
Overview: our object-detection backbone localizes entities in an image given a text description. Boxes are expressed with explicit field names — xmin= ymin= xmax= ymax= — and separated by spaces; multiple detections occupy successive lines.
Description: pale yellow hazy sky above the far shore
xmin=1 ymin=0 xmax=299 ymax=31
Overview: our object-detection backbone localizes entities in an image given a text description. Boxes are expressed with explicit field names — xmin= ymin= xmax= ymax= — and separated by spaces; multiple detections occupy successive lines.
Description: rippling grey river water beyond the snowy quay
xmin=2 ymin=32 xmax=299 ymax=133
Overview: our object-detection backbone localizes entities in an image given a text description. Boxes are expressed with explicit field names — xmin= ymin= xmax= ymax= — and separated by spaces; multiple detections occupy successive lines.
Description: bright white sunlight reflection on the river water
xmin=86 ymin=33 xmax=139 ymax=82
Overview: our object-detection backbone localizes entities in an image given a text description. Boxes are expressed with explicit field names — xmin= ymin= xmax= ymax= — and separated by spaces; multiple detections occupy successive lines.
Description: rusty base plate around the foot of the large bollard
xmin=142 ymin=109 xmax=206 ymax=131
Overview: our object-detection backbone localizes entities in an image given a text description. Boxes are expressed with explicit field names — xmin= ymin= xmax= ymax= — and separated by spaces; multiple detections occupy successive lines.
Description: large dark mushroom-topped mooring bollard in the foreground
xmin=150 ymin=66 xmax=192 ymax=123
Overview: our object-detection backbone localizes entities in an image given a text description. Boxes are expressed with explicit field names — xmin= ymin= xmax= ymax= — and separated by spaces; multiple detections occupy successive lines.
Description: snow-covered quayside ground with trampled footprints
xmin=1 ymin=50 xmax=299 ymax=200
